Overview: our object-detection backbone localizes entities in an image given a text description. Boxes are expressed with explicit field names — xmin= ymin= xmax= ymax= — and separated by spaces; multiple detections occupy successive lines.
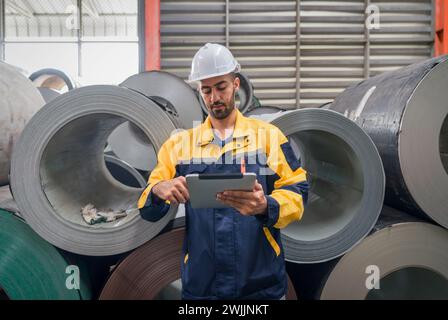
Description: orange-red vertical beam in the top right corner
xmin=434 ymin=0 xmax=448 ymax=56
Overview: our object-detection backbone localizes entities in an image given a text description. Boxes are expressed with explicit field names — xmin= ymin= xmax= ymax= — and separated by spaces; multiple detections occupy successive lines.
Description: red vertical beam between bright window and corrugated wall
xmin=145 ymin=0 xmax=160 ymax=71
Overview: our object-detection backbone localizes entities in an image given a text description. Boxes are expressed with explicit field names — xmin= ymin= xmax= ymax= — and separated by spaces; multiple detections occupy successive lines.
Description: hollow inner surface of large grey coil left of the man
xmin=39 ymin=114 xmax=142 ymax=228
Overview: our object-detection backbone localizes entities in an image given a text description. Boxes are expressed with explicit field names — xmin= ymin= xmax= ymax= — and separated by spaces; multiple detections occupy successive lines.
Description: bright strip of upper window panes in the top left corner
xmin=5 ymin=0 xmax=137 ymax=38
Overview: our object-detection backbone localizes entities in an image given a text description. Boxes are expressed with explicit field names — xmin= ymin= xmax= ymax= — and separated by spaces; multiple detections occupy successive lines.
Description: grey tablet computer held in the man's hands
xmin=185 ymin=172 xmax=257 ymax=209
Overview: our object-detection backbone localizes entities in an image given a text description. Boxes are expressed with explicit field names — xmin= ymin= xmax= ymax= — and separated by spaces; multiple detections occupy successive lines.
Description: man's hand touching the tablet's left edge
xmin=152 ymin=176 xmax=190 ymax=204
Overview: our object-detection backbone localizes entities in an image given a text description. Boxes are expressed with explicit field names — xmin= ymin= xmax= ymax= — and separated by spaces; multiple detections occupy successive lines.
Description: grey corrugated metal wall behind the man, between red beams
xmin=161 ymin=0 xmax=433 ymax=108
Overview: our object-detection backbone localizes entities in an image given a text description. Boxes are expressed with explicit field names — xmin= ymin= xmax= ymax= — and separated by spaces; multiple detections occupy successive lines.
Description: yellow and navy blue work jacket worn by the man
xmin=138 ymin=111 xmax=308 ymax=300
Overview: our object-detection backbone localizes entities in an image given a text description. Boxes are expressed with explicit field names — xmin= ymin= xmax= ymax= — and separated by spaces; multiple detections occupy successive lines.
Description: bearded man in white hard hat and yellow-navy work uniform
xmin=138 ymin=43 xmax=308 ymax=299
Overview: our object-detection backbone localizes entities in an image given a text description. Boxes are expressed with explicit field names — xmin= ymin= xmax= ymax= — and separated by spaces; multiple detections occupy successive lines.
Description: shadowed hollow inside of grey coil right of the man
xmin=282 ymin=130 xmax=364 ymax=241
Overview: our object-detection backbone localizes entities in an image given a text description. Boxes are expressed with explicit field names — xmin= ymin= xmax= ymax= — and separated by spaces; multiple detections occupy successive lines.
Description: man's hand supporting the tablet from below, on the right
xmin=217 ymin=181 xmax=268 ymax=216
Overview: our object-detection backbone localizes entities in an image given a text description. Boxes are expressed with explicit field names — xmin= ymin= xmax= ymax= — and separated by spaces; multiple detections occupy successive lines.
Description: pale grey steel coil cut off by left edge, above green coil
xmin=0 ymin=61 xmax=45 ymax=186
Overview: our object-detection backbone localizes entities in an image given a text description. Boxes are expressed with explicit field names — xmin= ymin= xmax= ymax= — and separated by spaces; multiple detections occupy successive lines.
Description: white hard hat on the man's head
xmin=188 ymin=43 xmax=241 ymax=82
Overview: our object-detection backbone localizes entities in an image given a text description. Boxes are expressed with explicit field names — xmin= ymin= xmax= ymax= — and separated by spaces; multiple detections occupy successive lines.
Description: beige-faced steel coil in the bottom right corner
xmin=288 ymin=206 xmax=448 ymax=300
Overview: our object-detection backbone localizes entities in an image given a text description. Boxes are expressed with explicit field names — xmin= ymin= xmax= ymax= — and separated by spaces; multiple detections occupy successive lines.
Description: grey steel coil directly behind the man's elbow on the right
xmin=252 ymin=108 xmax=385 ymax=263
